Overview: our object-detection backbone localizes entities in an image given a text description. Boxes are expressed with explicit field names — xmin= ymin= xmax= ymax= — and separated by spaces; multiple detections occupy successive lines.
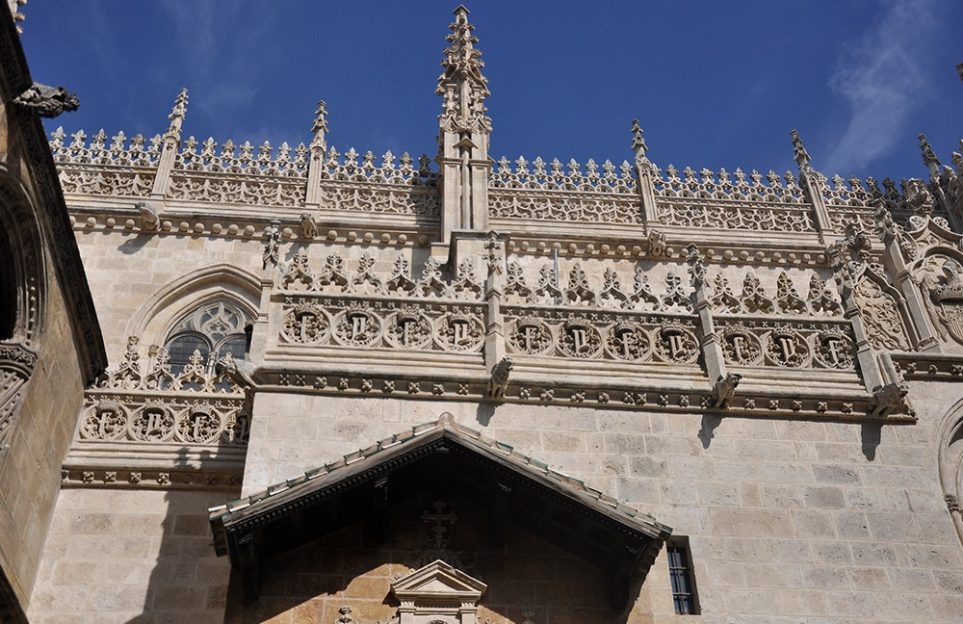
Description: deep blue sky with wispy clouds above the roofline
xmin=22 ymin=0 xmax=963 ymax=178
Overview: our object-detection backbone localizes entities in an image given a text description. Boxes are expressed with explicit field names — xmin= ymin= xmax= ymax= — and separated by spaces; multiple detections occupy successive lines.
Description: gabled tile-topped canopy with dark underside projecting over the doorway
xmin=210 ymin=413 xmax=671 ymax=604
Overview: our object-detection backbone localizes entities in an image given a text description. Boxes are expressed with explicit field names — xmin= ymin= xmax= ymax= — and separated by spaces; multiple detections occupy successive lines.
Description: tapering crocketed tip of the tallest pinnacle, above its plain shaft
xmin=435 ymin=5 xmax=491 ymax=132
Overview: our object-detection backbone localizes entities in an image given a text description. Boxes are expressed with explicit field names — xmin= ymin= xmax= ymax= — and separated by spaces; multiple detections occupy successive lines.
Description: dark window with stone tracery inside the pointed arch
xmin=164 ymin=301 xmax=251 ymax=375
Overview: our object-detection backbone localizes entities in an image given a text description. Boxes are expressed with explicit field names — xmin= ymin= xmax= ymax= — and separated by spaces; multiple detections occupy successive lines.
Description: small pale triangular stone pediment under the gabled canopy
xmin=391 ymin=559 xmax=487 ymax=624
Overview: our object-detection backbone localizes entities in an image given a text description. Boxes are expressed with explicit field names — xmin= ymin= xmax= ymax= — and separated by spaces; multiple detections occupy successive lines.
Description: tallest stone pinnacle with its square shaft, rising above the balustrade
xmin=435 ymin=6 xmax=492 ymax=243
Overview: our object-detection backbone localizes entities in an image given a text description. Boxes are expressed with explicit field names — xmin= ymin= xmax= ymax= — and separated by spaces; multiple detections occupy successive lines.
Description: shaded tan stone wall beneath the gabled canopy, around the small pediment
xmin=225 ymin=492 xmax=647 ymax=624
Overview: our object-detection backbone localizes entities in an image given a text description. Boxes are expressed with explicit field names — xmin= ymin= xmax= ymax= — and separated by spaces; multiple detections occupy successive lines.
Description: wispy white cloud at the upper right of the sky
xmin=824 ymin=0 xmax=936 ymax=173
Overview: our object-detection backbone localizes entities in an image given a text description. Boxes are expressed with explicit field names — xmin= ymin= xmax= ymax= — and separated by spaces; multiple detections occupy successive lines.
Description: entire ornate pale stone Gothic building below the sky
xmin=0 ymin=7 xmax=963 ymax=624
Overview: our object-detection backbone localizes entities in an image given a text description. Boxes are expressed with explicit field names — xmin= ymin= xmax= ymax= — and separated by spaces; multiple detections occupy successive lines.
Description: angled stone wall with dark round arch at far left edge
xmin=0 ymin=11 xmax=106 ymax=623
